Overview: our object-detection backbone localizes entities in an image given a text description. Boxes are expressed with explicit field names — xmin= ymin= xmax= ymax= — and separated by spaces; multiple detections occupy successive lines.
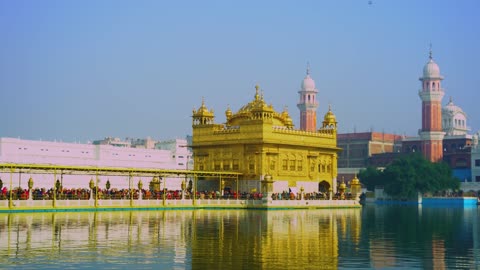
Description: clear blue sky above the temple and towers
xmin=0 ymin=0 xmax=480 ymax=142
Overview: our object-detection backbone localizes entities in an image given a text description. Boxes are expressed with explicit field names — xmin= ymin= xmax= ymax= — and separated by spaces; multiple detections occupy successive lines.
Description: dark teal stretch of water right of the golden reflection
xmin=362 ymin=206 xmax=480 ymax=269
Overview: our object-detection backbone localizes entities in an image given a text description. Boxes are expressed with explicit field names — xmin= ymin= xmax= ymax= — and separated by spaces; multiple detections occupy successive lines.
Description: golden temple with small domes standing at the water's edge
xmin=191 ymin=75 xmax=340 ymax=192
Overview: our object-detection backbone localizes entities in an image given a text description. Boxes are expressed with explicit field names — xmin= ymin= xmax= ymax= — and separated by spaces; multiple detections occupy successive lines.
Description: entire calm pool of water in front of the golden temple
xmin=0 ymin=205 xmax=480 ymax=269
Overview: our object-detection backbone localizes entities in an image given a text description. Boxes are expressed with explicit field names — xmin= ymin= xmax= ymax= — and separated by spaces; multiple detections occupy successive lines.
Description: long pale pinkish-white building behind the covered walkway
xmin=0 ymin=138 xmax=193 ymax=189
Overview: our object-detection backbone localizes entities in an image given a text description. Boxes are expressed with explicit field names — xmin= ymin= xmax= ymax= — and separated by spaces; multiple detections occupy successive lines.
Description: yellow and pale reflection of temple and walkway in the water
xmin=0 ymin=209 xmax=361 ymax=268
